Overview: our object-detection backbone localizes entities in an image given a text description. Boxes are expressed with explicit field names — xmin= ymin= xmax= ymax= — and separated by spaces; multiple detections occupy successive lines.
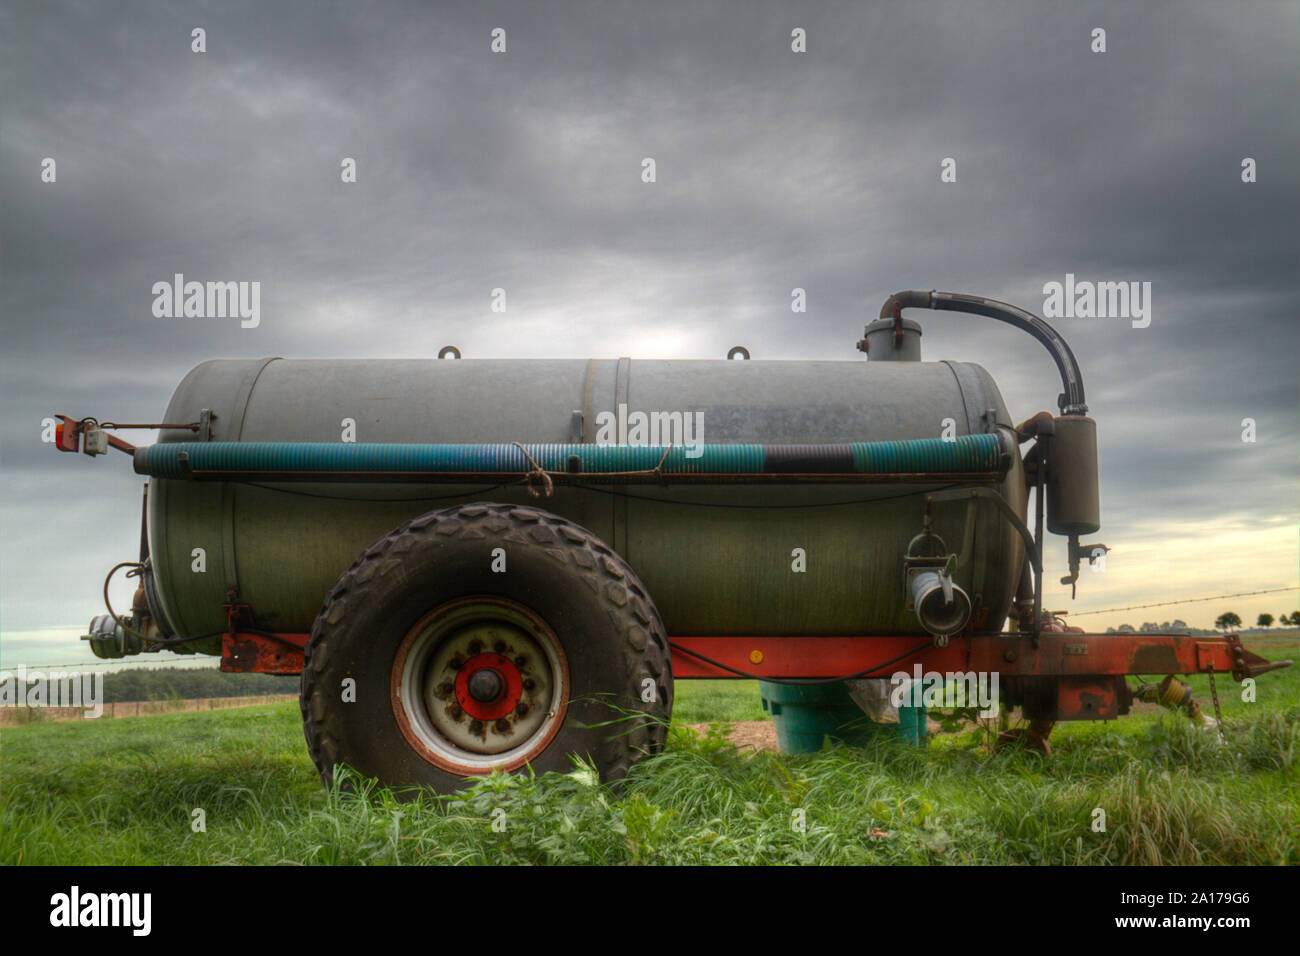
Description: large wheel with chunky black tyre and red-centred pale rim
xmin=300 ymin=502 xmax=672 ymax=796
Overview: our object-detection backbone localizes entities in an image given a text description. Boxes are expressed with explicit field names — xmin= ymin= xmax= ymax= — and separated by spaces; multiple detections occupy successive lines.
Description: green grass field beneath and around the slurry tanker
xmin=0 ymin=636 xmax=1300 ymax=865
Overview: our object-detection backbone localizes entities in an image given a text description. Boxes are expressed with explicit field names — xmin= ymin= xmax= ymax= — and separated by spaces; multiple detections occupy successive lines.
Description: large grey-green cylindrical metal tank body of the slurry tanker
xmin=148 ymin=359 xmax=1026 ymax=652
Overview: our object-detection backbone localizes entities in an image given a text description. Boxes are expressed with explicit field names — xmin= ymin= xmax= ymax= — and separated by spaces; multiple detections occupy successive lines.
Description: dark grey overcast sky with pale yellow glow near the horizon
xmin=0 ymin=0 xmax=1300 ymax=663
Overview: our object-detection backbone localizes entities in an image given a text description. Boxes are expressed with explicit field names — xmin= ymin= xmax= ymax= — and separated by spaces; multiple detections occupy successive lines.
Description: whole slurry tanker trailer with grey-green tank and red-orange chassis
xmin=56 ymin=291 xmax=1273 ymax=791
